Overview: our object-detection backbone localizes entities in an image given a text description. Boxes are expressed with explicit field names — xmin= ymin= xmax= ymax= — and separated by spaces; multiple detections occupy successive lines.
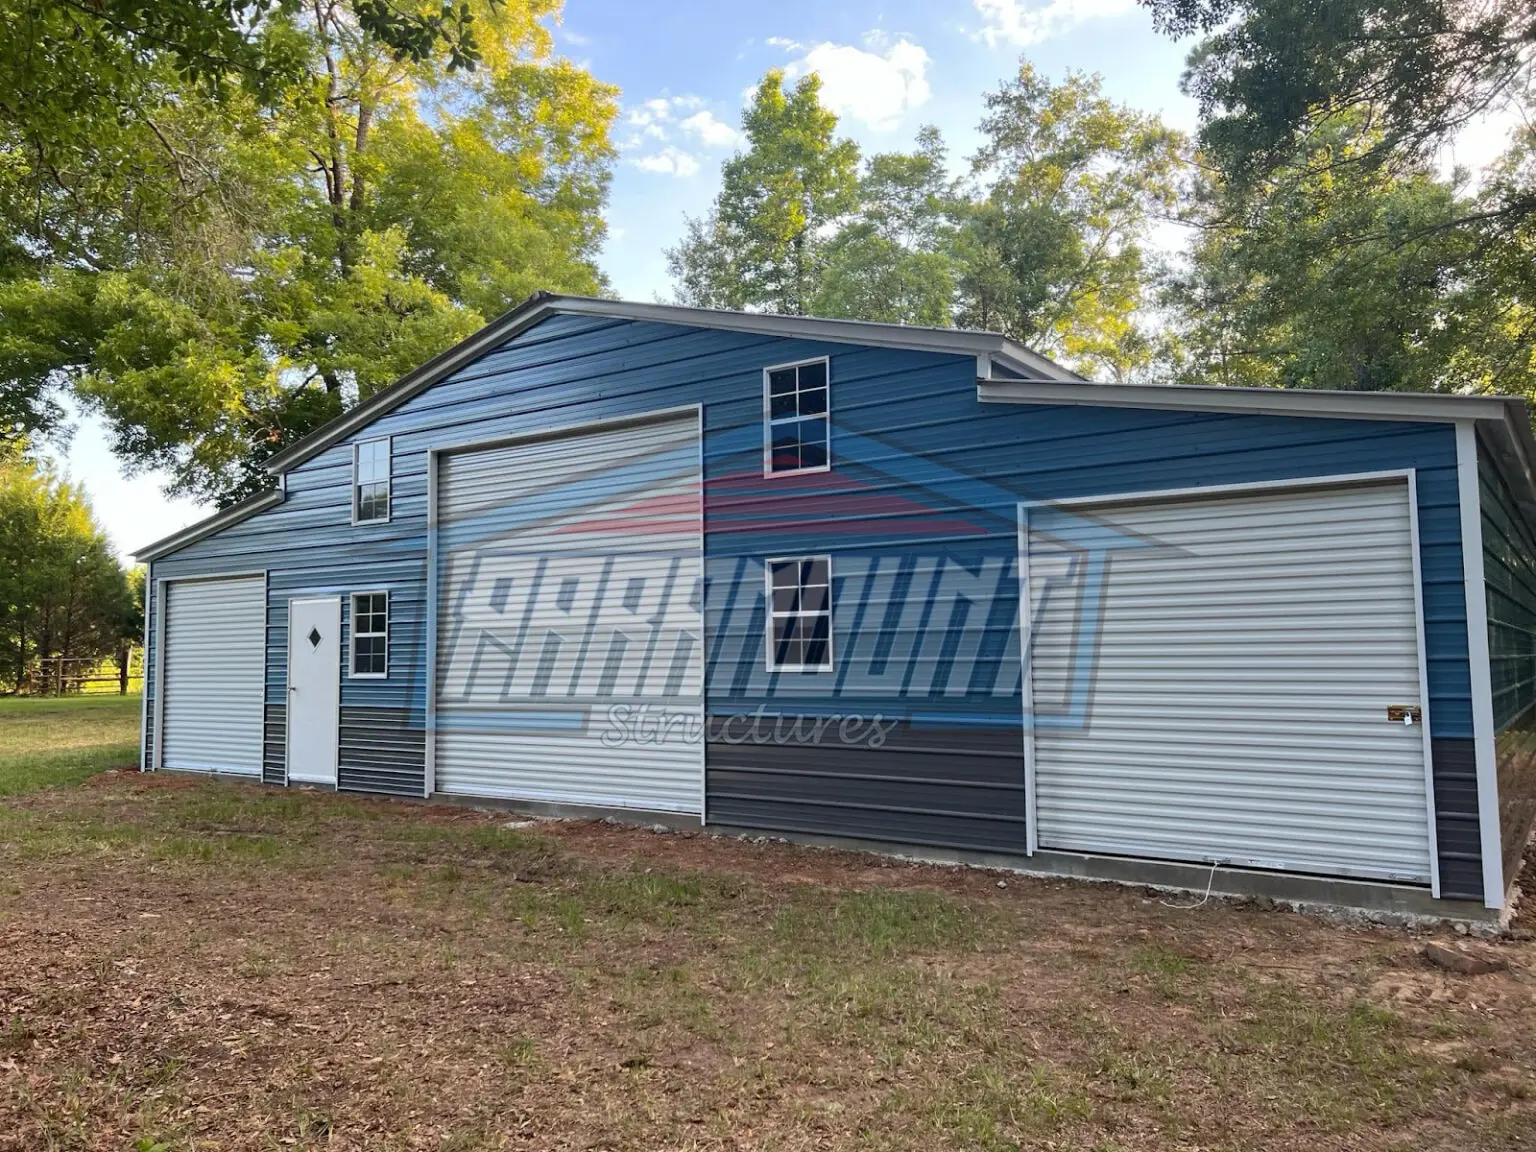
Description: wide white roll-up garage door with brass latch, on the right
xmin=1026 ymin=481 xmax=1432 ymax=883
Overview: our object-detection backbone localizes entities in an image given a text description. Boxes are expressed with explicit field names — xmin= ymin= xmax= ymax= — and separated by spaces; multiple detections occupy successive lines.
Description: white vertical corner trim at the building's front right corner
xmin=1456 ymin=421 xmax=1504 ymax=908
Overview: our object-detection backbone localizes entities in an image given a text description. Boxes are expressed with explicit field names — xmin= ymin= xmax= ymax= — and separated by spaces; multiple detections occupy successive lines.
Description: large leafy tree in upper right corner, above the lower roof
xmin=1143 ymin=0 xmax=1536 ymax=393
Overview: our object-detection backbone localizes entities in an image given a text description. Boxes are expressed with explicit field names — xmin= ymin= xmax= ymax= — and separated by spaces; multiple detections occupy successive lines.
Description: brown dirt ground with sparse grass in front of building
xmin=0 ymin=773 xmax=1536 ymax=1152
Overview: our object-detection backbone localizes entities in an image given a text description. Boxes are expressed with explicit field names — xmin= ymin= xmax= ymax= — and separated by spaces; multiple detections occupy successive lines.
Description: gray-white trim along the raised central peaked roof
xmin=266 ymin=292 xmax=1083 ymax=475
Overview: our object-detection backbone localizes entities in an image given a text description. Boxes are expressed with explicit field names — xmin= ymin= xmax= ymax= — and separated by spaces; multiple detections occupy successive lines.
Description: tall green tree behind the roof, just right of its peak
xmin=667 ymin=71 xmax=859 ymax=315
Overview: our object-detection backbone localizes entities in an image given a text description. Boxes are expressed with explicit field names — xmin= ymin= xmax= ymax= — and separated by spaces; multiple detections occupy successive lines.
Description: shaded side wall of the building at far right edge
xmin=1478 ymin=444 xmax=1536 ymax=885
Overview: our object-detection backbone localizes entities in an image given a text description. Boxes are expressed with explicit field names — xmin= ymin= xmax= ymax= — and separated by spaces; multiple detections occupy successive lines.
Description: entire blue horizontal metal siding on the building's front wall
xmin=146 ymin=316 xmax=1471 ymax=890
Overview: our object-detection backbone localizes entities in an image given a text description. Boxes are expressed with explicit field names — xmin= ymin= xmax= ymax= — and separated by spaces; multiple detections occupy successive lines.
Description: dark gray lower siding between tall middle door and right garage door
xmin=707 ymin=714 xmax=1026 ymax=852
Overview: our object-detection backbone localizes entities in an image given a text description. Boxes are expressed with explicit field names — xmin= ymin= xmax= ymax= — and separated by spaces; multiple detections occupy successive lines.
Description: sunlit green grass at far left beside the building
xmin=0 ymin=696 xmax=140 ymax=796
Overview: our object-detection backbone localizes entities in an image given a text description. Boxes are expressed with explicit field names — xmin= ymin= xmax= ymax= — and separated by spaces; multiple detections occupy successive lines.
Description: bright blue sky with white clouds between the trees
xmin=48 ymin=0 xmax=1523 ymax=559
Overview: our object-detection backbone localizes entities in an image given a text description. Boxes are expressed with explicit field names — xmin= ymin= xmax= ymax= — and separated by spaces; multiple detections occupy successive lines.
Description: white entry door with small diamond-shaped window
xmin=287 ymin=596 xmax=341 ymax=785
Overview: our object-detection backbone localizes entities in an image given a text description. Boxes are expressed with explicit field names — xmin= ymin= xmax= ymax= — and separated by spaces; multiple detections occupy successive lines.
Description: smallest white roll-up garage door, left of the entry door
xmin=160 ymin=576 xmax=267 ymax=776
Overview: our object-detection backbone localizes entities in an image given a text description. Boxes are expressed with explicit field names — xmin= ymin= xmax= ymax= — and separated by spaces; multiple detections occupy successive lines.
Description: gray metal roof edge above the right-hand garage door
xmin=977 ymin=379 xmax=1524 ymax=421
